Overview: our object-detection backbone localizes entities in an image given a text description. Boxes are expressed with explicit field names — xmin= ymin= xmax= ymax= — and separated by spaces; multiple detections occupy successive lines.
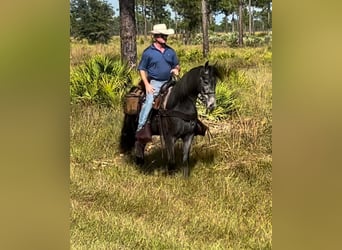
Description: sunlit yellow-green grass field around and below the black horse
xmin=70 ymin=38 xmax=272 ymax=249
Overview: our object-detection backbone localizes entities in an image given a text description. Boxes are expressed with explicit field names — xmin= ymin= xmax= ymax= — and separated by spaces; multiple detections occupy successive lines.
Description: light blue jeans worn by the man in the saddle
xmin=137 ymin=80 xmax=167 ymax=131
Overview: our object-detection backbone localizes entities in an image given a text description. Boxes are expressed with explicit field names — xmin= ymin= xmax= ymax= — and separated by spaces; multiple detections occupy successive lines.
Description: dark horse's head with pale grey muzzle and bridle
xmin=199 ymin=61 xmax=219 ymax=112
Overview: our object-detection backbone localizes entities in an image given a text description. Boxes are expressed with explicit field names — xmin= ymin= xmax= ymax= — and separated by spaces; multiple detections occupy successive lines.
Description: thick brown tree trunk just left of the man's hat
xmin=119 ymin=0 xmax=137 ymax=68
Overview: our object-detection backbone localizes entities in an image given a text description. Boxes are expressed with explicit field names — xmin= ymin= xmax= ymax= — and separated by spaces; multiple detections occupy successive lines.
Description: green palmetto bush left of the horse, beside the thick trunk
xmin=70 ymin=55 xmax=132 ymax=107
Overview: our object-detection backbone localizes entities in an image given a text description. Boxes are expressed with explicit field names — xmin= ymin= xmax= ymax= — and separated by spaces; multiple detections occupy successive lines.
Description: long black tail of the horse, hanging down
xmin=119 ymin=114 xmax=138 ymax=153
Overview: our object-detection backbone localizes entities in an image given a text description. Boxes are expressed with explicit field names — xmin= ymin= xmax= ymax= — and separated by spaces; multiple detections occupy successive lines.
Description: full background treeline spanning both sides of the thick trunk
xmin=70 ymin=0 xmax=272 ymax=43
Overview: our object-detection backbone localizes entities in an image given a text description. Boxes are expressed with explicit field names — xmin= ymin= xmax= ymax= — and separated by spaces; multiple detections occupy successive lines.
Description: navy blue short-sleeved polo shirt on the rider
xmin=138 ymin=44 xmax=179 ymax=81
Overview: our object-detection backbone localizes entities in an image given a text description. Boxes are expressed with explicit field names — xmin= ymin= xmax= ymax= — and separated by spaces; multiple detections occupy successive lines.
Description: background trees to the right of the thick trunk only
xmin=135 ymin=0 xmax=272 ymax=34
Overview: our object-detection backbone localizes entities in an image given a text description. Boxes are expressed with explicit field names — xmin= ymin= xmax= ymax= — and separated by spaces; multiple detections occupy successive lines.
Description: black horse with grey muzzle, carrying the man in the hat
xmin=120 ymin=62 xmax=221 ymax=177
